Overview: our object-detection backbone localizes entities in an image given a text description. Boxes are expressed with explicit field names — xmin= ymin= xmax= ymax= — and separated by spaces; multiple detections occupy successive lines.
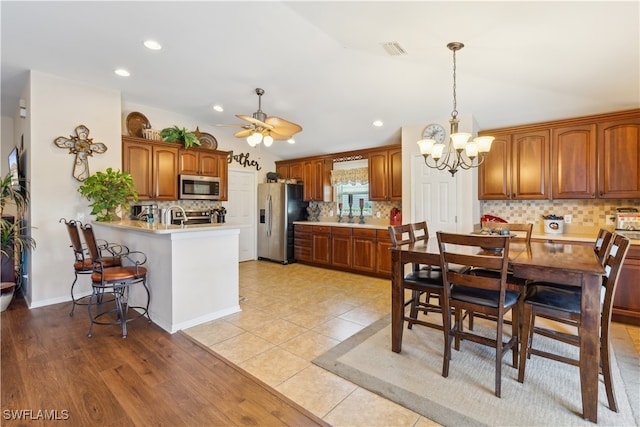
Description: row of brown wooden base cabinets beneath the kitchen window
xmin=294 ymin=224 xmax=391 ymax=278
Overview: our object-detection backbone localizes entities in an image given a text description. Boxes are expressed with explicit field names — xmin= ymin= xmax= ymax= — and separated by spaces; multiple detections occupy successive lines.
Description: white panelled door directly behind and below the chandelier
xmin=411 ymin=155 xmax=460 ymax=236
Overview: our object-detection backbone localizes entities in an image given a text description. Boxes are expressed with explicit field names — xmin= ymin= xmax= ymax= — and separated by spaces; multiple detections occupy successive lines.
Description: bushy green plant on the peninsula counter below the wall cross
xmin=78 ymin=168 xmax=138 ymax=221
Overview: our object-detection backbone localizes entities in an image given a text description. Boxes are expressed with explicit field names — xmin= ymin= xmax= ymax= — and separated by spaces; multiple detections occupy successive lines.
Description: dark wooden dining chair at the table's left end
xmin=389 ymin=224 xmax=442 ymax=330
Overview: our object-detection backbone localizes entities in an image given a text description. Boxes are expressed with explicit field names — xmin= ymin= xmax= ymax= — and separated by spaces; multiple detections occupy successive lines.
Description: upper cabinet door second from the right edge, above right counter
xmin=551 ymin=124 xmax=596 ymax=199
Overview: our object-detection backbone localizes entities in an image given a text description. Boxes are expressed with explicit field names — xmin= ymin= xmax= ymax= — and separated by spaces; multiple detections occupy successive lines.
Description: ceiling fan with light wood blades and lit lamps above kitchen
xmin=223 ymin=88 xmax=302 ymax=147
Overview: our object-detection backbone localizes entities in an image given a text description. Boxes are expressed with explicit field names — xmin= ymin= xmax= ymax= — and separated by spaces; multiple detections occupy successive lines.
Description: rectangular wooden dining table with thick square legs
xmin=390 ymin=237 xmax=604 ymax=423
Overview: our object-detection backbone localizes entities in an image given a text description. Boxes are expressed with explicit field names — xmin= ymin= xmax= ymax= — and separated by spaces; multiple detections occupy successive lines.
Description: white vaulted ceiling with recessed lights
xmin=0 ymin=1 xmax=640 ymax=158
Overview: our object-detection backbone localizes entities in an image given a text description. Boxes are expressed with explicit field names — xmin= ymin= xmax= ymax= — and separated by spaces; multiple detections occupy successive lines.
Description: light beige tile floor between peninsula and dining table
xmin=185 ymin=261 xmax=640 ymax=427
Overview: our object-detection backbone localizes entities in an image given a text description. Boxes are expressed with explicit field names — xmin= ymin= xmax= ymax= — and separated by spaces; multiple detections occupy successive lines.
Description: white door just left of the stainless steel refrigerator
xmin=222 ymin=168 xmax=258 ymax=261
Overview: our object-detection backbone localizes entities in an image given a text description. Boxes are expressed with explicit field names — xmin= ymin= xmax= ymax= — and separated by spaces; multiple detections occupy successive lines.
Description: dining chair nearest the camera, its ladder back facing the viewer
xmin=436 ymin=232 xmax=520 ymax=397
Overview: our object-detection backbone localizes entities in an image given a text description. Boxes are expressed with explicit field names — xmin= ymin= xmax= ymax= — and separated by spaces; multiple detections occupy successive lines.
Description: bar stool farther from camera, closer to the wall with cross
xmin=58 ymin=218 xmax=128 ymax=316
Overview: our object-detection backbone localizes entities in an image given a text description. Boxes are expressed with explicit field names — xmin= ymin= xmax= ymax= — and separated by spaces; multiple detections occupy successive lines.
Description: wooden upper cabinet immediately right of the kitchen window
xmin=368 ymin=146 xmax=402 ymax=201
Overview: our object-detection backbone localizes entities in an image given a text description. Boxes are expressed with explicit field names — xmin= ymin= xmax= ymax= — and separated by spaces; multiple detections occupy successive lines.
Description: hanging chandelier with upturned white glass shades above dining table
xmin=418 ymin=42 xmax=494 ymax=176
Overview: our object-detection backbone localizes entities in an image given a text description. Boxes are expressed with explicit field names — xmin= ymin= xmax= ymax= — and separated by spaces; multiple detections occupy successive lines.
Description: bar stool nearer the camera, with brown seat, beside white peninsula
xmin=81 ymin=224 xmax=151 ymax=338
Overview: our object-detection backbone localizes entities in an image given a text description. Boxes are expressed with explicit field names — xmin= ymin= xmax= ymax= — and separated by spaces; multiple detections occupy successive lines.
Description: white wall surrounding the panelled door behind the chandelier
xmin=401 ymin=116 xmax=480 ymax=230
